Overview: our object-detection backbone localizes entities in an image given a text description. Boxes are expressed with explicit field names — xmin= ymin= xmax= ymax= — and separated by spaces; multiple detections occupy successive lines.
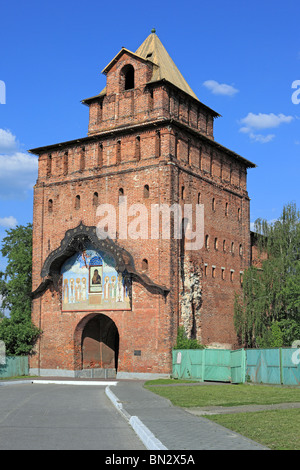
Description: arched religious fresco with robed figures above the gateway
xmin=61 ymin=248 xmax=131 ymax=311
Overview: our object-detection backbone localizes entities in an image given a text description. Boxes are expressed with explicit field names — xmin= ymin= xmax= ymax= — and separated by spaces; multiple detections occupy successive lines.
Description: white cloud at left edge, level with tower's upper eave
xmin=0 ymin=129 xmax=38 ymax=199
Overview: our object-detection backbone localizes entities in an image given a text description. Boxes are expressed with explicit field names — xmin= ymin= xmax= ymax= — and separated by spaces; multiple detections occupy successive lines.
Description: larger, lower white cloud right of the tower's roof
xmin=240 ymin=113 xmax=294 ymax=144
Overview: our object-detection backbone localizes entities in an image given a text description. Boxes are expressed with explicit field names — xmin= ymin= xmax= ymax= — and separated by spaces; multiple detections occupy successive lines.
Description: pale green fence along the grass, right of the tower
xmin=172 ymin=348 xmax=300 ymax=385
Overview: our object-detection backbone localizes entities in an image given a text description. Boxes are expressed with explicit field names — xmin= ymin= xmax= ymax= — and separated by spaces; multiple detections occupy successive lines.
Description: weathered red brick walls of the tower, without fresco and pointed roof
xmin=31 ymin=31 xmax=254 ymax=374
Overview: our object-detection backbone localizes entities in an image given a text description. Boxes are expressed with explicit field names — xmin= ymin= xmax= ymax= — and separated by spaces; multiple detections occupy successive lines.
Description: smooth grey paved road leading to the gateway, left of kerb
xmin=0 ymin=384 xmax=145 ymax=450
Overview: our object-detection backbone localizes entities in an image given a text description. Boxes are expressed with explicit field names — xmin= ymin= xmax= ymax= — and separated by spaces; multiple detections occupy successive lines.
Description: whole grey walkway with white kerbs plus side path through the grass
xmin=0 ymin=377 xmax=288 ymax=451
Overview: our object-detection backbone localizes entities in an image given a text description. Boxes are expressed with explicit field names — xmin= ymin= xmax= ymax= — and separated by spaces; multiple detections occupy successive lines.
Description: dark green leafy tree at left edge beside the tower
xmin=0 ymin=224 xmax=40 ymax=355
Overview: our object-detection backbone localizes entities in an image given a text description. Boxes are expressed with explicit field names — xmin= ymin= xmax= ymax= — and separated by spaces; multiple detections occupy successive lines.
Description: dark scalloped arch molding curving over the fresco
xmin=32 ymin=222 xmax=169 ymax=298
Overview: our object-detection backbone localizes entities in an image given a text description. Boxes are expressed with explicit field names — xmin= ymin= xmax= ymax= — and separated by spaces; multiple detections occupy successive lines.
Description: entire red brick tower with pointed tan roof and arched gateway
xmin=30 ymin=31 xmax=255 ymax=377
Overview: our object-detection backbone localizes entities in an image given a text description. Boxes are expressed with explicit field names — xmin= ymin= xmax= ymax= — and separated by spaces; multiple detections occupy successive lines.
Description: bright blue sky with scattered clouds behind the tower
xmin=0 ymin=0 xmax=300 ymax=270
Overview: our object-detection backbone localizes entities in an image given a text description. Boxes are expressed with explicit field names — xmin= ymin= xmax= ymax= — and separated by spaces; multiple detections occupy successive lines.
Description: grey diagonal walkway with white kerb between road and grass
xmin=107 ymin=381 xmax=268 ymax=450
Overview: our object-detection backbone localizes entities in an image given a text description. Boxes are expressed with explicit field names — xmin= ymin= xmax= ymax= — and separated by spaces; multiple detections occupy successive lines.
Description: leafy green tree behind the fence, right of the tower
xmin=234 ymin=203 xmax=300 ymax=347
